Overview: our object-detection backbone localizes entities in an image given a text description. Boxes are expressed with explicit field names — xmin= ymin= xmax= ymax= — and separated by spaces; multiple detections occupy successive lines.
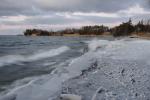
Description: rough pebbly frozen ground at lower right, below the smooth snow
xmin=62 ymin=58 xmax=150 ymax=100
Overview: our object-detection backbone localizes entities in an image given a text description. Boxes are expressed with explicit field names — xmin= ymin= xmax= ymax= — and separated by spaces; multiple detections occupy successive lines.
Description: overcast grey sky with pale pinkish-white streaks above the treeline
xmin=0 ymin=0 xmax=150 ymax=35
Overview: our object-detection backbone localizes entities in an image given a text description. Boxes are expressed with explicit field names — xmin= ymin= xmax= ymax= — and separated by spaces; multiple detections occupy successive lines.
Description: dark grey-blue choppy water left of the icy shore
xmin=0 ymin=36 xmax=111 ymax=91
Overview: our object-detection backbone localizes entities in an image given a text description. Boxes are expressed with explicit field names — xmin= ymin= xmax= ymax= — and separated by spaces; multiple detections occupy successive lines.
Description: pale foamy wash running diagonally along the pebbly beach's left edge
xmin=0 ymin=47 xmax=96 ymax=100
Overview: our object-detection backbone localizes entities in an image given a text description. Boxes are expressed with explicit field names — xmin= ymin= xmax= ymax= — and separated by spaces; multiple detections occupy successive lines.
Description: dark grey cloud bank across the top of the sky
xmin=0 ymin=0 xmax=146 ymax=16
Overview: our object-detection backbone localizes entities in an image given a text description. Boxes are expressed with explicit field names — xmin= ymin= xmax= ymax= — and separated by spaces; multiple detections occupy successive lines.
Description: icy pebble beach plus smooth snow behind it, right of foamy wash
xmin=56 ymin=40 xmax=150 ymax=100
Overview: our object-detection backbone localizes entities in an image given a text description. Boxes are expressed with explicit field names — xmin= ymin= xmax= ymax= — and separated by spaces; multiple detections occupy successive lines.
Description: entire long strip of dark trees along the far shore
xmin=24 ymin=19 xmax=150 ymax=37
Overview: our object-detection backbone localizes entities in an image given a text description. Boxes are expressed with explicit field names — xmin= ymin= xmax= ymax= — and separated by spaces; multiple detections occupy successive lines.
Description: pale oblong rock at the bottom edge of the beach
xmin=60 ymin=94 xmax=82 ymax=100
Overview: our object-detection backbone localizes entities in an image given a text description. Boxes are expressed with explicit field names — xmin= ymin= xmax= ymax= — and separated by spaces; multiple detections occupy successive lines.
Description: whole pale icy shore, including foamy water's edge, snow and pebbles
xmin=0 ymin=39 xmax=150 ymax=100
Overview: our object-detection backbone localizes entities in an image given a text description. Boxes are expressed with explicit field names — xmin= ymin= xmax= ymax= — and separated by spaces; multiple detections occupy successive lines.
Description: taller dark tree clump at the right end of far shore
xmin=110 ymin=19 xmax=150 ymax=36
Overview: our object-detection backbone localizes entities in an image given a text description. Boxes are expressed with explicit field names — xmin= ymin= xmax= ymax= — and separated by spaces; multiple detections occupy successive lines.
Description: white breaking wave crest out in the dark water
xmin=0 ymin=46 xmax=70 ymax=67
